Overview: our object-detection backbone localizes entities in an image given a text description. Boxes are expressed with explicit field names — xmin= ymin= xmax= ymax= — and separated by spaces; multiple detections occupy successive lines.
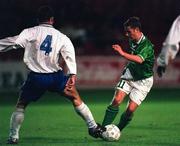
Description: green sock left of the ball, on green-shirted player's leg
xmin=102 ymin=105 xmax=119 ymax=126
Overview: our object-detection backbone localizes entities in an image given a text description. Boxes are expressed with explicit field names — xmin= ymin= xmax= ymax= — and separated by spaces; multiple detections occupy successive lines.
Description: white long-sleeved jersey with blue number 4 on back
xmin=0 ymin=24 xmax=77 ymax=74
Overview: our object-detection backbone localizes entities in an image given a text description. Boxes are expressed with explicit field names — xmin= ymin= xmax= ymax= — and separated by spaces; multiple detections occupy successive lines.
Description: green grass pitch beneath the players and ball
xmin=0 ymin=89 xmax=180 ymax=146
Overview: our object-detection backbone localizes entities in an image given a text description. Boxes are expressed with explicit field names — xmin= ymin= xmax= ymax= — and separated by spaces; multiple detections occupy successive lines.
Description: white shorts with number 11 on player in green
xmin=116 ymin=76 xmax=153 ymax=105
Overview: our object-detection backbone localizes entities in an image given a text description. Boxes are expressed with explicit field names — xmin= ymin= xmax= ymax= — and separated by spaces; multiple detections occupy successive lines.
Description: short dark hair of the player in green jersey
xmin=124 ymin=16 xmax=141 ymax=30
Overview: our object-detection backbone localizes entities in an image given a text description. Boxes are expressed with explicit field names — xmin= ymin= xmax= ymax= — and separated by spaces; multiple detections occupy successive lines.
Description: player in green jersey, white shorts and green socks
xmin=102 ymin=17 xmax=155 ymax=131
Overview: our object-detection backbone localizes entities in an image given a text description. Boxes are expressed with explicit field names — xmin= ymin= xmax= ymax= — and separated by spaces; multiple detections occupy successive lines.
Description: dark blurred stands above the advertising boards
xmin=0 ymin=0 xmax=180 ymax=60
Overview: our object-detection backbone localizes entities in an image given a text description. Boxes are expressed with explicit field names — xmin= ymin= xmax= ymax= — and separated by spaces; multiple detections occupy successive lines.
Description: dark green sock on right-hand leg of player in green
xmin=118 ymin=112 xmax=133 ymax=131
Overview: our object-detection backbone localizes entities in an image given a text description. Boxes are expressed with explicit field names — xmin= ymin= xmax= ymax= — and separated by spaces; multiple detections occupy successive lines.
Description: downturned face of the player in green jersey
xmin=125 ymin=26 xmax=138 ymax=40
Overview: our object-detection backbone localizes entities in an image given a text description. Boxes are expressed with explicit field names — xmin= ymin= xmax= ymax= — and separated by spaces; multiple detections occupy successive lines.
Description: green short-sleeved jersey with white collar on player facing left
xmin=126 ymin=36 xmax=155 ymax=81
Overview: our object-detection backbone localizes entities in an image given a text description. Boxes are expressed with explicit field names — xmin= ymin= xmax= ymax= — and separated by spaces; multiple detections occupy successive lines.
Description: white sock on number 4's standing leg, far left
xmin=9 ymin=108 xmax=24 ymax=139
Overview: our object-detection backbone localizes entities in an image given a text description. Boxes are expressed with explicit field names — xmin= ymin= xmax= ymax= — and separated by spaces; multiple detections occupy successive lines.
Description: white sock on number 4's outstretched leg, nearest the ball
xmin=75 ymin=102 xmax=97 ymax=128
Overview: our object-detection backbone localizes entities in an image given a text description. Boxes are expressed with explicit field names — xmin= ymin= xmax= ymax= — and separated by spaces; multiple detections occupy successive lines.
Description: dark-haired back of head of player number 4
xmin=37 ymin=6 xmax=54 ymax=22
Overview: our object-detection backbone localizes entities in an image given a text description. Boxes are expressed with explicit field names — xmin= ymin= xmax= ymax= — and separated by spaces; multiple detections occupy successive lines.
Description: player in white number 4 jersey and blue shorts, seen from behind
xmin=0 ymin=6 xmax=105 ymax=144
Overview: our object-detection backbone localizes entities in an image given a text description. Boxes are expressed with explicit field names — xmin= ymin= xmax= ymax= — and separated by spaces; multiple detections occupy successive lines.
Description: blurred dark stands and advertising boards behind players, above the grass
xmin=0 ymin=0 xmax=180 ymax=90
